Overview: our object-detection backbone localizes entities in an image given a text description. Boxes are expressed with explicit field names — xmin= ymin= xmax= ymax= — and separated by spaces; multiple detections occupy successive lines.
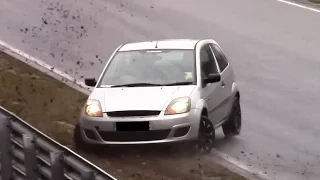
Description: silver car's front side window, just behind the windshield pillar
xmin=200 ymin=45 xmax=218 ymax=78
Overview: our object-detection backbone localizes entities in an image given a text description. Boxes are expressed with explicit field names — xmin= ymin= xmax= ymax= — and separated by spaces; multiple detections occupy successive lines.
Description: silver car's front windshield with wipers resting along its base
xmin=99 ymin=50 xmax=195 ymax=87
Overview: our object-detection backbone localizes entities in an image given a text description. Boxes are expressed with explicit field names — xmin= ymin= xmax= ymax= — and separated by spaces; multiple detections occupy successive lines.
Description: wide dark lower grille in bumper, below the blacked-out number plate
xmin=99 ymin=129 xmax=170 ymax=142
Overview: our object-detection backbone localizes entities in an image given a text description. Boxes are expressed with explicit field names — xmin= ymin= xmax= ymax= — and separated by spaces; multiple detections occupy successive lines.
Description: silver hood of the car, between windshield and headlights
xmin=89 ymin=85 xmax=195 ymax=112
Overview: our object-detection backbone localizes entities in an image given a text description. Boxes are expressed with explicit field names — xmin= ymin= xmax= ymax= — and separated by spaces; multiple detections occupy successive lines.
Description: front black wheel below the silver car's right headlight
xmin=195 ymin=116 xmax=215 ymax=153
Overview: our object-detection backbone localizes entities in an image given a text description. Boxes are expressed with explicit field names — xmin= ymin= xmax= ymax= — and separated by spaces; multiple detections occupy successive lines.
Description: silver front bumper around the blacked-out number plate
xmin=79 ymin=109 xmax=201 ymax=144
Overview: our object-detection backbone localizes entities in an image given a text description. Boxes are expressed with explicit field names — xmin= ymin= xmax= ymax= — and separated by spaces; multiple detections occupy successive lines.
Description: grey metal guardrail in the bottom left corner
xmin=0 ymin=106 xmax=116 ymax=180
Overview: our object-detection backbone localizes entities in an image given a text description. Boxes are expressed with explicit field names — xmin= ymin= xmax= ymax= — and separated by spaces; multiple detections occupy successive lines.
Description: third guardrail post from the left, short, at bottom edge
xmin=50 ymin=151 xmax=65 ymax=180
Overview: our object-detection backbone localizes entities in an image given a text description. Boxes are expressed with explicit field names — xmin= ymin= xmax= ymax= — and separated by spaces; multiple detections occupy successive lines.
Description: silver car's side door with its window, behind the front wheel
xmin=200 ymin=44 xmax=224 ymax=125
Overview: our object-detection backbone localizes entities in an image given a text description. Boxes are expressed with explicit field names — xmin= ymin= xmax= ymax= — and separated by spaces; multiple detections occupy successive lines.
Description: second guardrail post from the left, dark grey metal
xmin=22 ymin=134 xmax=38 ymax=180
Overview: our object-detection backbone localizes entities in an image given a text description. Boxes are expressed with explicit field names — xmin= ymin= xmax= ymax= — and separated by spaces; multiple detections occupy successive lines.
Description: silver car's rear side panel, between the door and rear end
xmin=210 ymin=43 xmax=233 ymax=120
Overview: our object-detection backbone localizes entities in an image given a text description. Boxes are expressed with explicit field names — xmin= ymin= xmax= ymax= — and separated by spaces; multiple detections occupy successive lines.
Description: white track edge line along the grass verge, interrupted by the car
xmin=0 ymin=40 xmax=270 ymax=180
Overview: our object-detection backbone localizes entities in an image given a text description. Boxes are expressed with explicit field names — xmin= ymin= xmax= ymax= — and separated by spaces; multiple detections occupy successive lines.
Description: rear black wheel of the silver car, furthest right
xmin=222 ymin=97 xmax=242 ymax=137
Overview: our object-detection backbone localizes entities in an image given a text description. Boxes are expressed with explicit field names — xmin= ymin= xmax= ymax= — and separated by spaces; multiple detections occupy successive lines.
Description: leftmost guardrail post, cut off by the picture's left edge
xmin=0 ymin=115 xmax=13 ymax=180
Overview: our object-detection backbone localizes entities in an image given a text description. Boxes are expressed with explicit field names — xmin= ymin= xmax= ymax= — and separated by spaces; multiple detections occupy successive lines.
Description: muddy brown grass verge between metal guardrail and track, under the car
xmin=0 ymin=52 xmax=245 ymax=180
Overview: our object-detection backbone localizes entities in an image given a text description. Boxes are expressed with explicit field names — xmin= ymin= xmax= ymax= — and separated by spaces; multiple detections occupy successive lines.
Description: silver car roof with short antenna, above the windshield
xmin=119 ymin=39 xmax=200 ymax=51
